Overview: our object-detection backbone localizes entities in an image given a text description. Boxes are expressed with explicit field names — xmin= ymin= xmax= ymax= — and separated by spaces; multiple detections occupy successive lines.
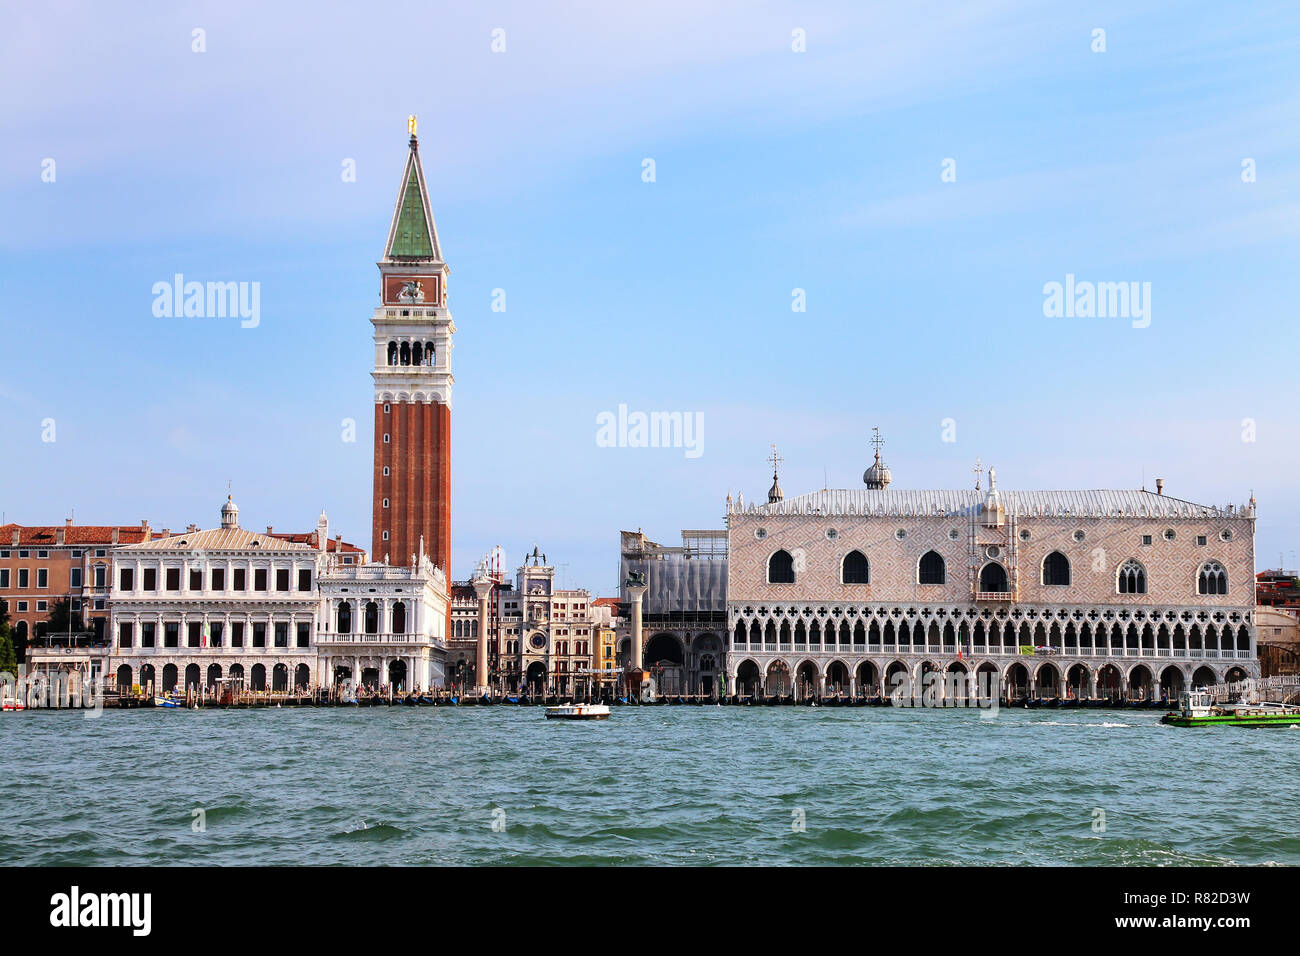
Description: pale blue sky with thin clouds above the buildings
xmin=0 ymin=0 xmax=1300 ymax=593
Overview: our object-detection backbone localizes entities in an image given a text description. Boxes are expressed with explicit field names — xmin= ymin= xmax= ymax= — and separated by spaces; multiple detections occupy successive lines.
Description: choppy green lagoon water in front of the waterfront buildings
xmin=0 ymin=706 xmax=1300 ymax=866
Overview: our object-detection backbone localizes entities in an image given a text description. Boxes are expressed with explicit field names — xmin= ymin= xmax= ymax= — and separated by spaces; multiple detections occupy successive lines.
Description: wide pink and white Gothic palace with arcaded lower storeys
xmin=727 ymin=475 xmax=1258 ymax=697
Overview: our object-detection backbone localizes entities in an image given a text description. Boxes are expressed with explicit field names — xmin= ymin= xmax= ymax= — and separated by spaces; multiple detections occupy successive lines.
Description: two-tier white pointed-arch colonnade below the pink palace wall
xmin=725 ymin=605 xmax=1258 ymax=700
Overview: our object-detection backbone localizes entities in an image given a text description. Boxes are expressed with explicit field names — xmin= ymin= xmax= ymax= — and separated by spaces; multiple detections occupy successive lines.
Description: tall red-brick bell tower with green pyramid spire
xmin=371 ymin=116 xmax=456 ymax=580
